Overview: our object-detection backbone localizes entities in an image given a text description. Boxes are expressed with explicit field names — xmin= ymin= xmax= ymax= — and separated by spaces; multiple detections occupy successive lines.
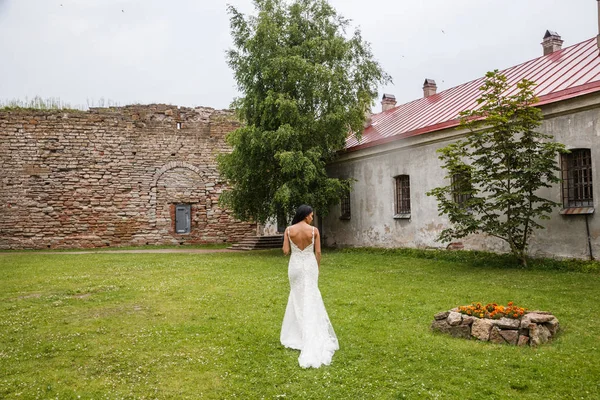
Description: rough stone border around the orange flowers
xmin=431 ymin=308 xmax=560 ymax=347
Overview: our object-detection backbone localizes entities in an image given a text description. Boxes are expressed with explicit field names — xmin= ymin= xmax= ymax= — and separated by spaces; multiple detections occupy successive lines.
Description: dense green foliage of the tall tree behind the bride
xmin=218 ymin=0 xmax=389 ymax=222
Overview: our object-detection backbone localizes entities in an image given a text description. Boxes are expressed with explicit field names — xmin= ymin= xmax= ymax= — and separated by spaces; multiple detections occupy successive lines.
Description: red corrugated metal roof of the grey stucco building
xmin=346 ymin=38 xmax=600 ymax=151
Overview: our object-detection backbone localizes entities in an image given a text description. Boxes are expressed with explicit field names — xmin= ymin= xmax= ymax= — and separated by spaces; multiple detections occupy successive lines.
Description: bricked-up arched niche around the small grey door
xmin=148 ymin=161 xmax=214 ymax=228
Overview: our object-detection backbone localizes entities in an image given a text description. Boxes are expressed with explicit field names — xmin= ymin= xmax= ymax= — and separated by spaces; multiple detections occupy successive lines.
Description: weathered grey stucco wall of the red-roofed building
xmin=323 ymin=93 xmax=600 ymax=258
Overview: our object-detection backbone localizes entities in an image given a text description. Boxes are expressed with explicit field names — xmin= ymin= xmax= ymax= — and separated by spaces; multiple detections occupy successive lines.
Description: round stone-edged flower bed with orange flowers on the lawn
xmin=431 ymin=302 xmax=559 ymax=346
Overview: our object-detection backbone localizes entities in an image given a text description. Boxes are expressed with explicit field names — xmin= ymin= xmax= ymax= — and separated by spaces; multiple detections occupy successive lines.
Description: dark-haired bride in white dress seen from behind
xmin=281 ymin=205 xmax=339 ymax=368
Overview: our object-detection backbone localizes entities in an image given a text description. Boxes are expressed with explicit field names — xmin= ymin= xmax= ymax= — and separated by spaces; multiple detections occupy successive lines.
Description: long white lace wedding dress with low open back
xmin=281 ymin=228 xmax=339 ymax=368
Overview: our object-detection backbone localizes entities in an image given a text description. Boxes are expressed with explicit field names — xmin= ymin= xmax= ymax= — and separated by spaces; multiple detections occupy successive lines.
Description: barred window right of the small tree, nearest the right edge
xmin=561 ymin=149 xmax=594 ymax=208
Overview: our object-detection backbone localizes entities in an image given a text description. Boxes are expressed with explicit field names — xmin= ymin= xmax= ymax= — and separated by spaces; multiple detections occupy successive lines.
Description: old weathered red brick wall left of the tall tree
xmin=0 ymin=105 xmax=255 ymax=249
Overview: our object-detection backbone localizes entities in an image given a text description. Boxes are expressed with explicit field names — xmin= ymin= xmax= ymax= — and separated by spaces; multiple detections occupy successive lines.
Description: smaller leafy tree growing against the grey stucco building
xmin=428 ymin=71 xmax=566 ymax=265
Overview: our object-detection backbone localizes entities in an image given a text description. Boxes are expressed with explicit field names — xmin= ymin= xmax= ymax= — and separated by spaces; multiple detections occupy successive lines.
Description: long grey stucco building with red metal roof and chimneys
xmin=321 ymin=28 xmax=600 ymax=258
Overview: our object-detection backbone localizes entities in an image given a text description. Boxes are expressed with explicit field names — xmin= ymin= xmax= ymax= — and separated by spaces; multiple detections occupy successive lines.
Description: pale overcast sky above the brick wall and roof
xmin=0 ymin=0 xmax=598 ymax=111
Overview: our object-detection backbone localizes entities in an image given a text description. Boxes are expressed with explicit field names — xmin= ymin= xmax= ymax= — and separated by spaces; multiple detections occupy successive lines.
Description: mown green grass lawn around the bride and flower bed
xmin=0 ymin=250 xmax=600 ymax=399
